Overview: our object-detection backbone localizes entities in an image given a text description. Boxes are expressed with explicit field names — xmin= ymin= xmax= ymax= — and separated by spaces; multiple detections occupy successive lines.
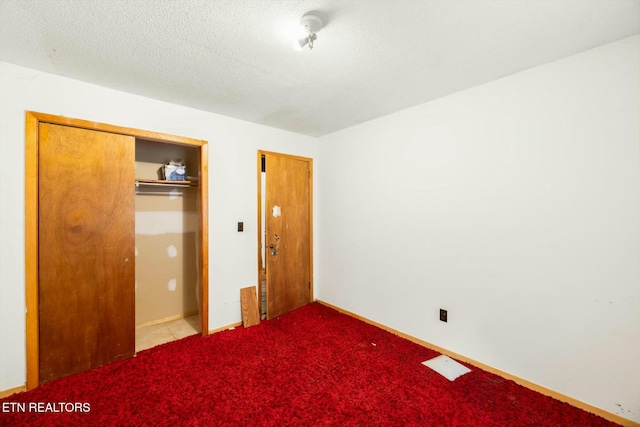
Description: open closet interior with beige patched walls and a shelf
xmin=135 ymin=138 xmax=202 ymax=352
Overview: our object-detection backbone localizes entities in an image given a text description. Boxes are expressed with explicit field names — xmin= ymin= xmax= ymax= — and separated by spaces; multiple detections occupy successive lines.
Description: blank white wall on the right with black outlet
xmin=317 ymin=37 xmax=640 ymax=421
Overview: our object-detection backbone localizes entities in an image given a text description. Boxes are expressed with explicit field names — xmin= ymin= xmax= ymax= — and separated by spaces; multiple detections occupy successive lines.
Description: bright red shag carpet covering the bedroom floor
xmin=0 ymin=304 xmax=616 ymax=427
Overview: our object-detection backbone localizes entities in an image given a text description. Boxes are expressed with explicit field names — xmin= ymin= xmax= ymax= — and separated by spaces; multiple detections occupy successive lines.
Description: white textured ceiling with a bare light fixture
xmin=0 ymin=0 xmax=640 ymax=136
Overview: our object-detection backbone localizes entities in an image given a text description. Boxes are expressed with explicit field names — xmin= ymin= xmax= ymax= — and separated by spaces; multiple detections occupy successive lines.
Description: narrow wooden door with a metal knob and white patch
xmin=265 ymin=153 xmax=311 ymax=319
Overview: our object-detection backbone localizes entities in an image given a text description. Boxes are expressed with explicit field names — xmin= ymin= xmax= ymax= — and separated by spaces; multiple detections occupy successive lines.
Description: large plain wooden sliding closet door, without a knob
xmin=38 ymin=124 xmax=135 ymax=383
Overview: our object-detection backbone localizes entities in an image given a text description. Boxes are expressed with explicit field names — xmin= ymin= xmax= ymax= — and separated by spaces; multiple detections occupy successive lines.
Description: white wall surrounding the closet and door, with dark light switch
xmin=0 ymin=62 xmax=317 ymax=391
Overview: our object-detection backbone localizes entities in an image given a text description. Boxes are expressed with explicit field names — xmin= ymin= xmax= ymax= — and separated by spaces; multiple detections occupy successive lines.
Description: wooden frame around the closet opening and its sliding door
xmin=25 ymin=111 xmax=209 ymax=390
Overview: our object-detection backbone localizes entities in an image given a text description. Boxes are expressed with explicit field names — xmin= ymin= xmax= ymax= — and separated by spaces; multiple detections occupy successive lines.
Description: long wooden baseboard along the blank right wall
xmin=316 ymin=300 xmax=640 ymax=427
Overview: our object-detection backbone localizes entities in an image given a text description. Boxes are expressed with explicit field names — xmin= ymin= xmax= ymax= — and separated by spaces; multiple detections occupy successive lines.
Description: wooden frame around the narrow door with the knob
xmin=257 ymin=150 xmax=315 ymax=318
